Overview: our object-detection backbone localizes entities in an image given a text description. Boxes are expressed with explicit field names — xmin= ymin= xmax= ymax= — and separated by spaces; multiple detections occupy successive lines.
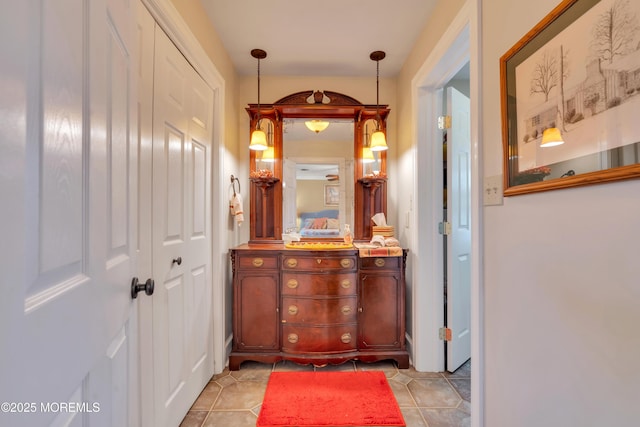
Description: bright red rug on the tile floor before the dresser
xmin=256 ymin=371 xmax=406 ymax=427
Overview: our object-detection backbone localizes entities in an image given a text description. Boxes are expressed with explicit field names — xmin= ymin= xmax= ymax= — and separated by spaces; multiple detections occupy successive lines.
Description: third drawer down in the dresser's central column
xmin=281 ymin=295 xmax=357 ymax=325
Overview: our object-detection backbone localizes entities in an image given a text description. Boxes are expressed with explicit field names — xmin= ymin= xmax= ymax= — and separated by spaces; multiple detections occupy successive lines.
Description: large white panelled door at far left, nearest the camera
xmin=0 ymin=0 xmax=137 ymax=426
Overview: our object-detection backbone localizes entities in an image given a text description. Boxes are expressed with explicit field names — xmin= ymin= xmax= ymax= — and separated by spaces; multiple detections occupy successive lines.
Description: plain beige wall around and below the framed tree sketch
xmin=481 ymin=0 xmax=640 ymax=427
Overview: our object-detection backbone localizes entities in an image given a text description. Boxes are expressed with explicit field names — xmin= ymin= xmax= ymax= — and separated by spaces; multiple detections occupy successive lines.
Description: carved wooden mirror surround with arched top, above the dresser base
xmin=246 ymin=91 xmax=389 ymax=243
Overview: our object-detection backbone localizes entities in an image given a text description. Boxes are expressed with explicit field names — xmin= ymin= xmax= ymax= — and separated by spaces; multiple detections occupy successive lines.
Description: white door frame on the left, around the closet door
xmin=141 ymin=0 xmax=229 ymax=373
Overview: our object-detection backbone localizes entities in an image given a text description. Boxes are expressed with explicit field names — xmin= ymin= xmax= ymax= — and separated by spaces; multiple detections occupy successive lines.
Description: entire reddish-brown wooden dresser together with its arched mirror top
xmin=234 ymin=90 xmax=409 ymax=370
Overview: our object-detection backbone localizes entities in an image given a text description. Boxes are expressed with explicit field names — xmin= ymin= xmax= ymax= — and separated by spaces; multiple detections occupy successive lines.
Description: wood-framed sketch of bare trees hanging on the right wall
xmin=500 ymin=0 xmax=640 ymax=196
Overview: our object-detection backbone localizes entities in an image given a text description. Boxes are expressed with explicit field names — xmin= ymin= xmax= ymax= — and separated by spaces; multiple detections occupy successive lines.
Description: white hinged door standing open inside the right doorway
xmin=447 ymin=87 xmax=471 ymax=372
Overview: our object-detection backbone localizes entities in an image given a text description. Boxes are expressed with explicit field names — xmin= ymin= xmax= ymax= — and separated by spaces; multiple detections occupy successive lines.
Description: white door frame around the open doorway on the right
xmin=412 ymin=0 xmax=484 ymax=427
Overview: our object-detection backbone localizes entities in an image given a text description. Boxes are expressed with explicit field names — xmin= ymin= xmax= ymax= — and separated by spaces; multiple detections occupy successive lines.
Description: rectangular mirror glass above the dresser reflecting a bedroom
xmin=282 ymin=118 xmax=354 ymax=239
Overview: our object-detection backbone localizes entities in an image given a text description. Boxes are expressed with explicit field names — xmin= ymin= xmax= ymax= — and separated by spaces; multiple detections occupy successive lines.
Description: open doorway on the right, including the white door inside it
xmin=438 ymin=62 xmax=471 ymax=372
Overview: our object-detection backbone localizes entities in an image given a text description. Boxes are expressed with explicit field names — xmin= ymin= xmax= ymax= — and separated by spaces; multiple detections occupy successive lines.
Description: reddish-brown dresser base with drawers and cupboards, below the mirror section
xmin=229 ymin=243 xmax=409 ymax=370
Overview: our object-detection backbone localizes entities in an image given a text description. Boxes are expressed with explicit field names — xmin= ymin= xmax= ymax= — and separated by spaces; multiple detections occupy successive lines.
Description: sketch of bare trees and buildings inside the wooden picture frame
xmin=515 ymin=0 xmax=640 ymax=171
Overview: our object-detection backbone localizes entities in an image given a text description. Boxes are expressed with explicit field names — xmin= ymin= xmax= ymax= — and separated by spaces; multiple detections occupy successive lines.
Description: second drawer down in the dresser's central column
xmin=282 ymin=273 xmax=358 ymax=296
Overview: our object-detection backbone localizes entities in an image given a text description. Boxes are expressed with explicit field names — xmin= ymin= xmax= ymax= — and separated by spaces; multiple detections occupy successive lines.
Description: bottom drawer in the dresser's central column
xmin=282 ymin=324 xmax=357 ymax=353
